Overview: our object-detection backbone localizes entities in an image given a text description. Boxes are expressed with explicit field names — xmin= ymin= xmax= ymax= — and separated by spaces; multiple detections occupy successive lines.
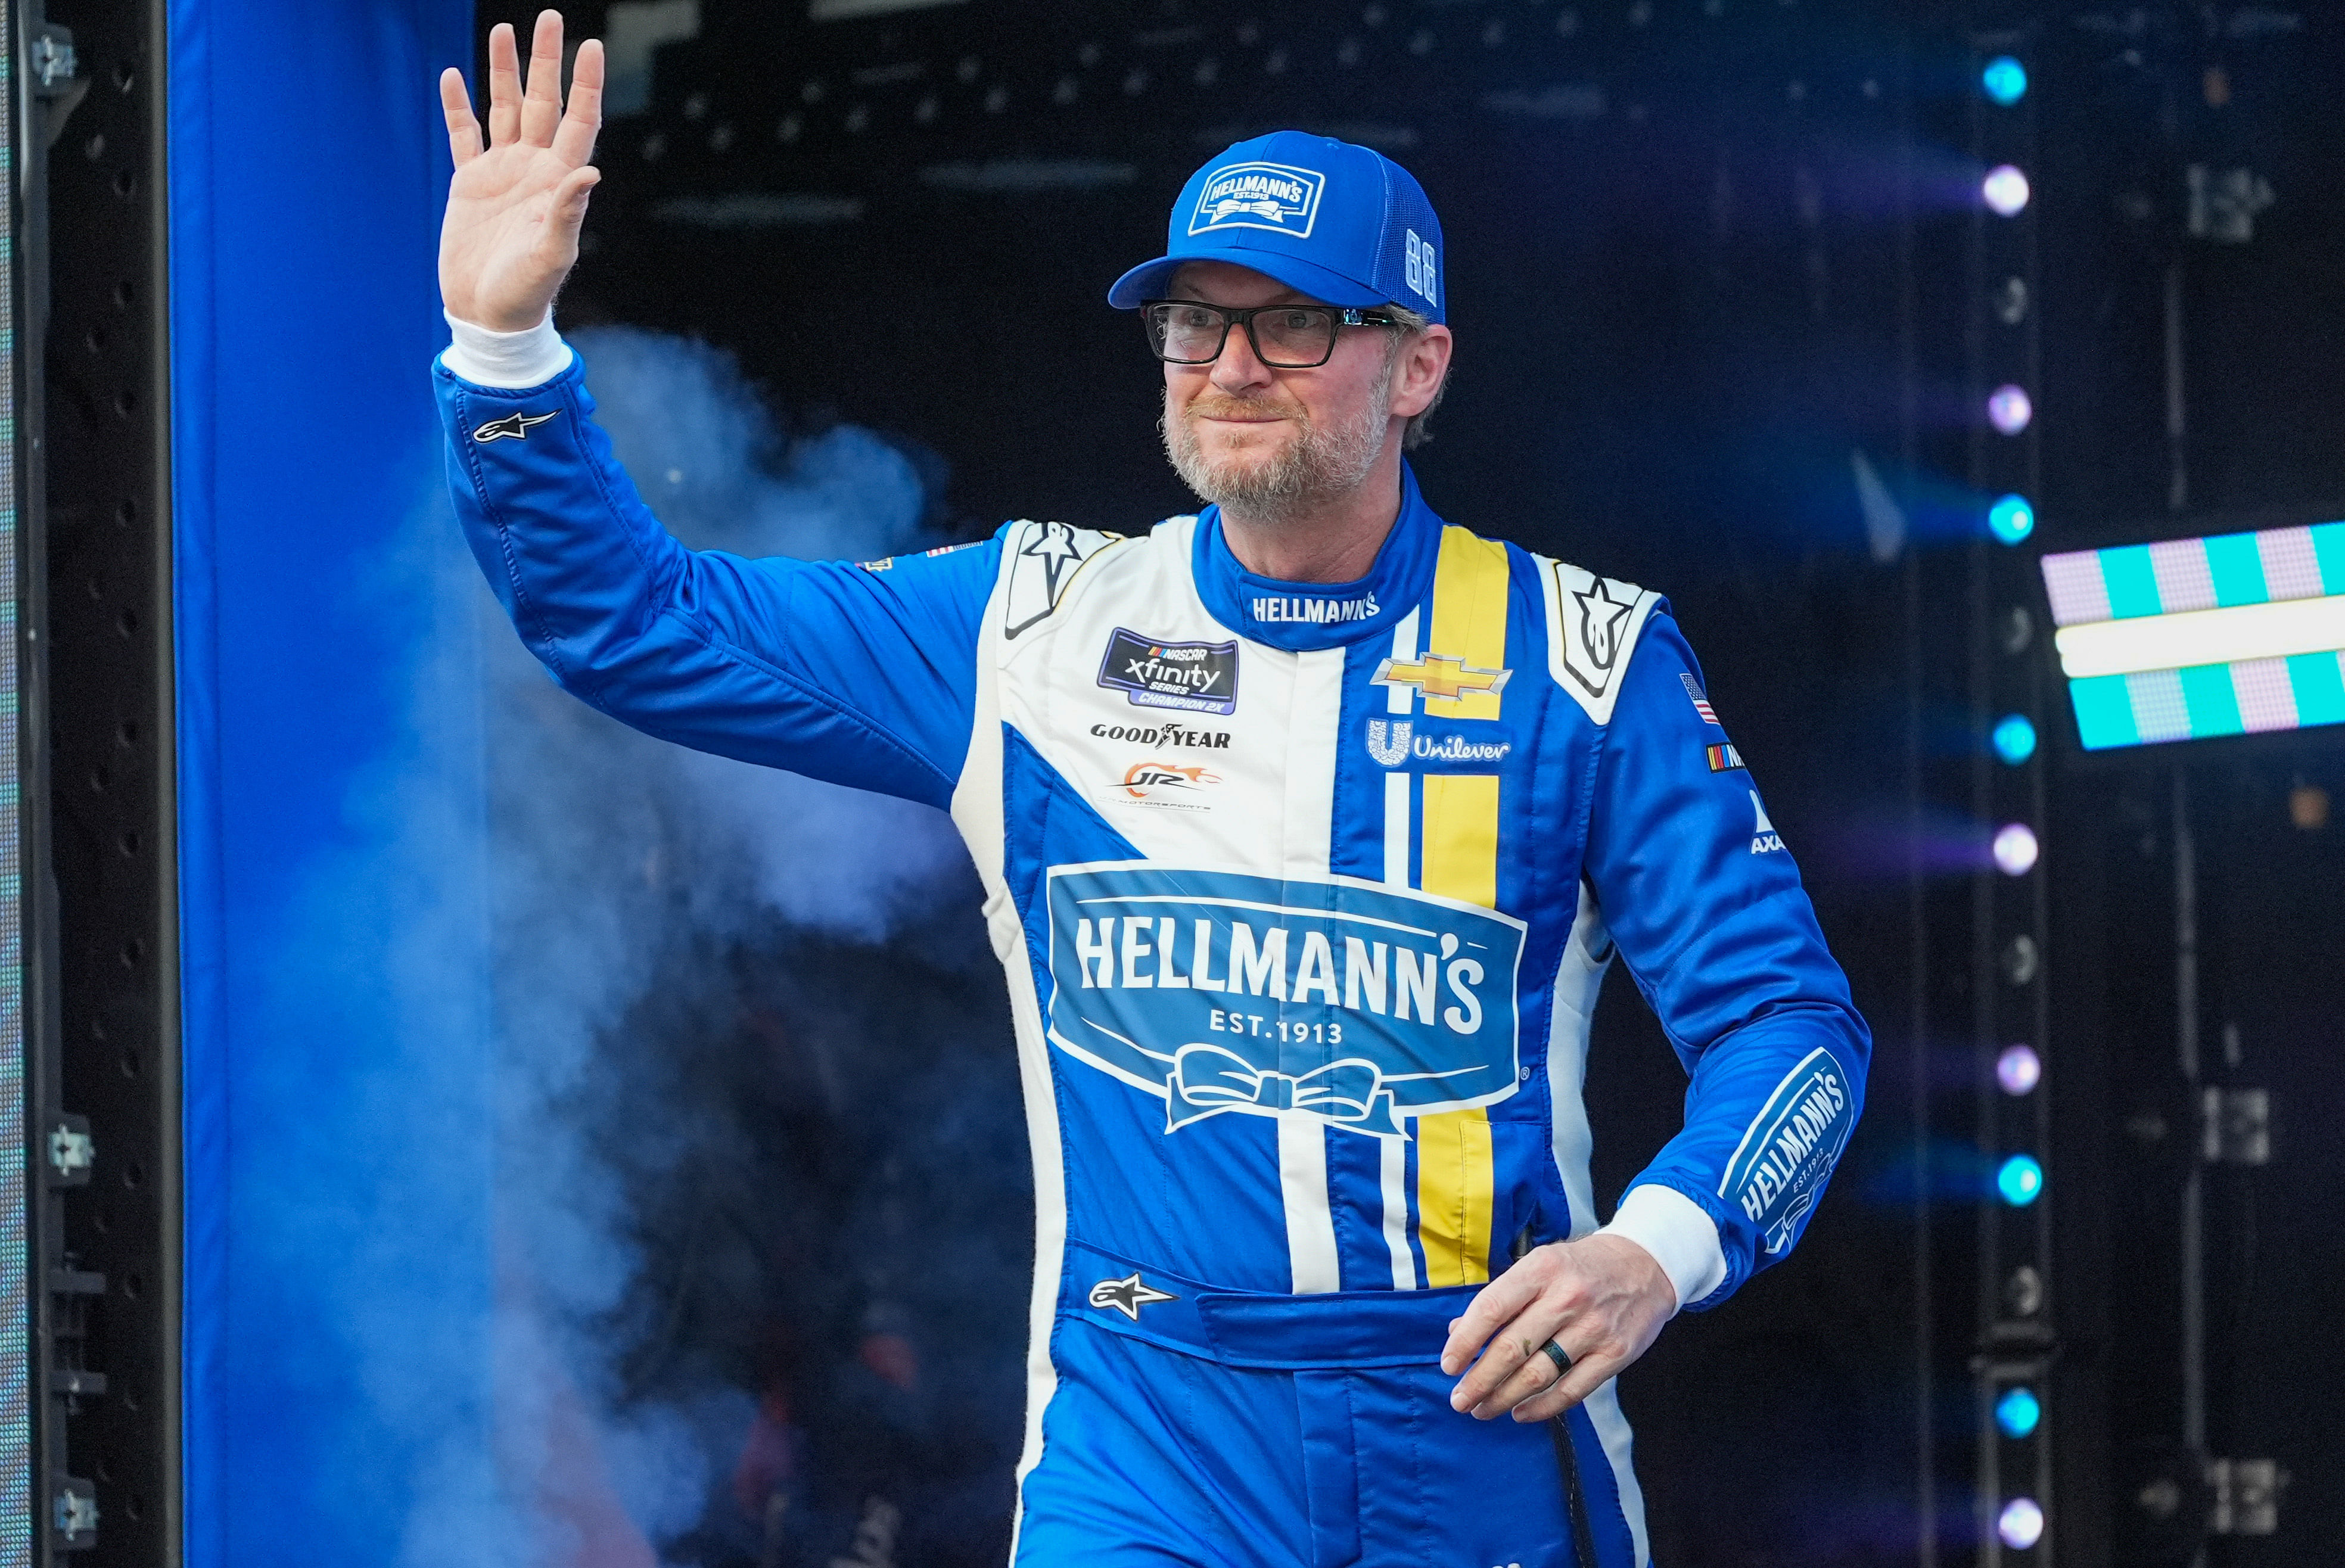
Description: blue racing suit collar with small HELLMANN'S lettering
xmin=1193 ymin=462 xmax=1442 ymax=654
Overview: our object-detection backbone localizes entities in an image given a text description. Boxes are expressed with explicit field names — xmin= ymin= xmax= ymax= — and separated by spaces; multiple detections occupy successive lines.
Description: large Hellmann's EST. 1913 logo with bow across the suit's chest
xmin=1048 ymin=860 xmax=1524 ymax=1137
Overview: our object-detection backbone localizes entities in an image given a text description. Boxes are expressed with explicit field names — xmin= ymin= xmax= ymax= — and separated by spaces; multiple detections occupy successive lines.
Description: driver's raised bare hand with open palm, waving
xmin=441 ymin=12 xmax=603 ymax=333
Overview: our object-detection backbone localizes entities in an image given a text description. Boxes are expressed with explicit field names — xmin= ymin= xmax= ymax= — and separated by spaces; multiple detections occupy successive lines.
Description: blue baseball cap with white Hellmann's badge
xmin=1107 ymin=131 xmax=1447 ymax=321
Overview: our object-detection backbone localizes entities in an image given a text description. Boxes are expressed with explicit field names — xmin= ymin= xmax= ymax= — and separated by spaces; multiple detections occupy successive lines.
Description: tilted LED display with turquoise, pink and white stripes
xmin=2042 ymin=522 xmax=2345 ymax=750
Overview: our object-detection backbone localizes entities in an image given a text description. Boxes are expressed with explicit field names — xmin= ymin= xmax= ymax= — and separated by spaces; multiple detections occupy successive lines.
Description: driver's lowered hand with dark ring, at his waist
xmin=1442 ymin=1233 xmax=1677 ymax=1420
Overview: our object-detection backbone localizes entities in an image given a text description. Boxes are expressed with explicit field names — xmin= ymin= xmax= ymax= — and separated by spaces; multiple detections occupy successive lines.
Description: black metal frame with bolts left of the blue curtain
xmin=21 ymin=0 xmax=181 ymax=1566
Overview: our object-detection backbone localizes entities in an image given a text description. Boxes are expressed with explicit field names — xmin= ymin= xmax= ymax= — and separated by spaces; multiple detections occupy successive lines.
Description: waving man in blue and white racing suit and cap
xmin=438 ymin=12 xmax=1869 ymax=1568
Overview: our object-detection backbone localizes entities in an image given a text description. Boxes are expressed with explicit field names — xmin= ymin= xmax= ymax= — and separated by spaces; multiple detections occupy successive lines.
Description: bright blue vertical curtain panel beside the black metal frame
xmin=169 ymin=0 xmax=480 ymax=1568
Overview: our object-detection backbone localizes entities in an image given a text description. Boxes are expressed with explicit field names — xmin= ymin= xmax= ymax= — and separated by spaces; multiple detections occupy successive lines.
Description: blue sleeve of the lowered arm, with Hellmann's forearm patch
xmin=1585 ymin=607 xmax=1871 ymax=1308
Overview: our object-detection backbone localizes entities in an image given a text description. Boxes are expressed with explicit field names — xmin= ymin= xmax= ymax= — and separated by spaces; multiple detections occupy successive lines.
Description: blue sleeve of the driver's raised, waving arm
xmin=434 ymin=359 xmax=1002 ymax=806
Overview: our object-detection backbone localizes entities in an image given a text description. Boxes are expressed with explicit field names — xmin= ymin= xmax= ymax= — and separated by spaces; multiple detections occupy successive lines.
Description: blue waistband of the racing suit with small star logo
xmin=1058 ymin=1237 xmax=1482 ymax=1371
